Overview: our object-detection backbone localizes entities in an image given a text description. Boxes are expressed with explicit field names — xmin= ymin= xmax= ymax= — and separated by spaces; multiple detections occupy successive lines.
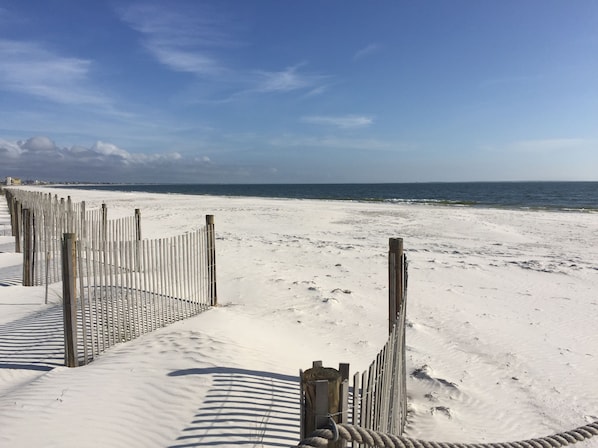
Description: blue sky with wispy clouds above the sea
xmin=0 ymin=0 xmax=598 ymax=183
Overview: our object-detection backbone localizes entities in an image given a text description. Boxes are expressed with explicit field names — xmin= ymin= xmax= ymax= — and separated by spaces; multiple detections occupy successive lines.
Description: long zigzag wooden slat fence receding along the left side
xmin=5 ymin=189 xmax=217 ymax=367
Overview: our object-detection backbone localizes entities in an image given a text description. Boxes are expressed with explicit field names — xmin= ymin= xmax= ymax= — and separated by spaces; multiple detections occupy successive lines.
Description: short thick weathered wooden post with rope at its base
xmin=300 ymin=361 xmax=345 ymax=448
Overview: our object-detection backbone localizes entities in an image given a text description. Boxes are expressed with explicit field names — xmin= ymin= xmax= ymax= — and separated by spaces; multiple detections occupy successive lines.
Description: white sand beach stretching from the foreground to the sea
xmin=0 ymin=188 xmax=598 ymax=448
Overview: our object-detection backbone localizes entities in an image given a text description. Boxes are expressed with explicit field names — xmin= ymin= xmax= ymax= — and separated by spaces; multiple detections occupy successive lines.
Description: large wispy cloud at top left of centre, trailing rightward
xmin=119 ymin=4 xmax=326 ymax=99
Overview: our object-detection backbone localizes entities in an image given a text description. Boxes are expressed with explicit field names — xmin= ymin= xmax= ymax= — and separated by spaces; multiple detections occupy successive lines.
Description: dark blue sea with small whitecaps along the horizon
xmin=62 ymin=182 xmax=598 ymax=212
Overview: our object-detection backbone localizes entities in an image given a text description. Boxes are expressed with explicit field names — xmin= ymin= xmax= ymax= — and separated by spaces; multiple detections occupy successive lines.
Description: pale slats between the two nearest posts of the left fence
xmin=73 ymin=226 xmax=215 ymax=364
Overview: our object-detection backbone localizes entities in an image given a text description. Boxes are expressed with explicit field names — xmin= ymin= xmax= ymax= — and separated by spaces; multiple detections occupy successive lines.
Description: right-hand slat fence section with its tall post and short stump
xmin=300 ymin=238 xmax=408 ymax=448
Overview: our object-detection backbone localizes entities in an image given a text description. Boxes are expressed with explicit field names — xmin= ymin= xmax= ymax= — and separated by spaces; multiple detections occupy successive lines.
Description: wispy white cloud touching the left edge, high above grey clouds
xmin=0 ymin=39 xmax=109 ymax=106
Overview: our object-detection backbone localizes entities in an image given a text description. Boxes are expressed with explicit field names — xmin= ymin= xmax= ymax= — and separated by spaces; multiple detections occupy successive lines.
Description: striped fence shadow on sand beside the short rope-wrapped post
xmin=168 ymin=367 xmax=300 ymax=448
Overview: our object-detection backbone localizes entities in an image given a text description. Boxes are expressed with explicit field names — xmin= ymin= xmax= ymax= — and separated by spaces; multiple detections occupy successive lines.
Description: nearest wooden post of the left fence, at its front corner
xmin=62 ymin=233 xmax=79 ymax=367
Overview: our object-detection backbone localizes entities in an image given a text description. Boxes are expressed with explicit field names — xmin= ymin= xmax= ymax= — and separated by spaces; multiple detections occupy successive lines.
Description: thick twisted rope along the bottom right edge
xmin=297 ymin=419 xmax=598 ymax=448
